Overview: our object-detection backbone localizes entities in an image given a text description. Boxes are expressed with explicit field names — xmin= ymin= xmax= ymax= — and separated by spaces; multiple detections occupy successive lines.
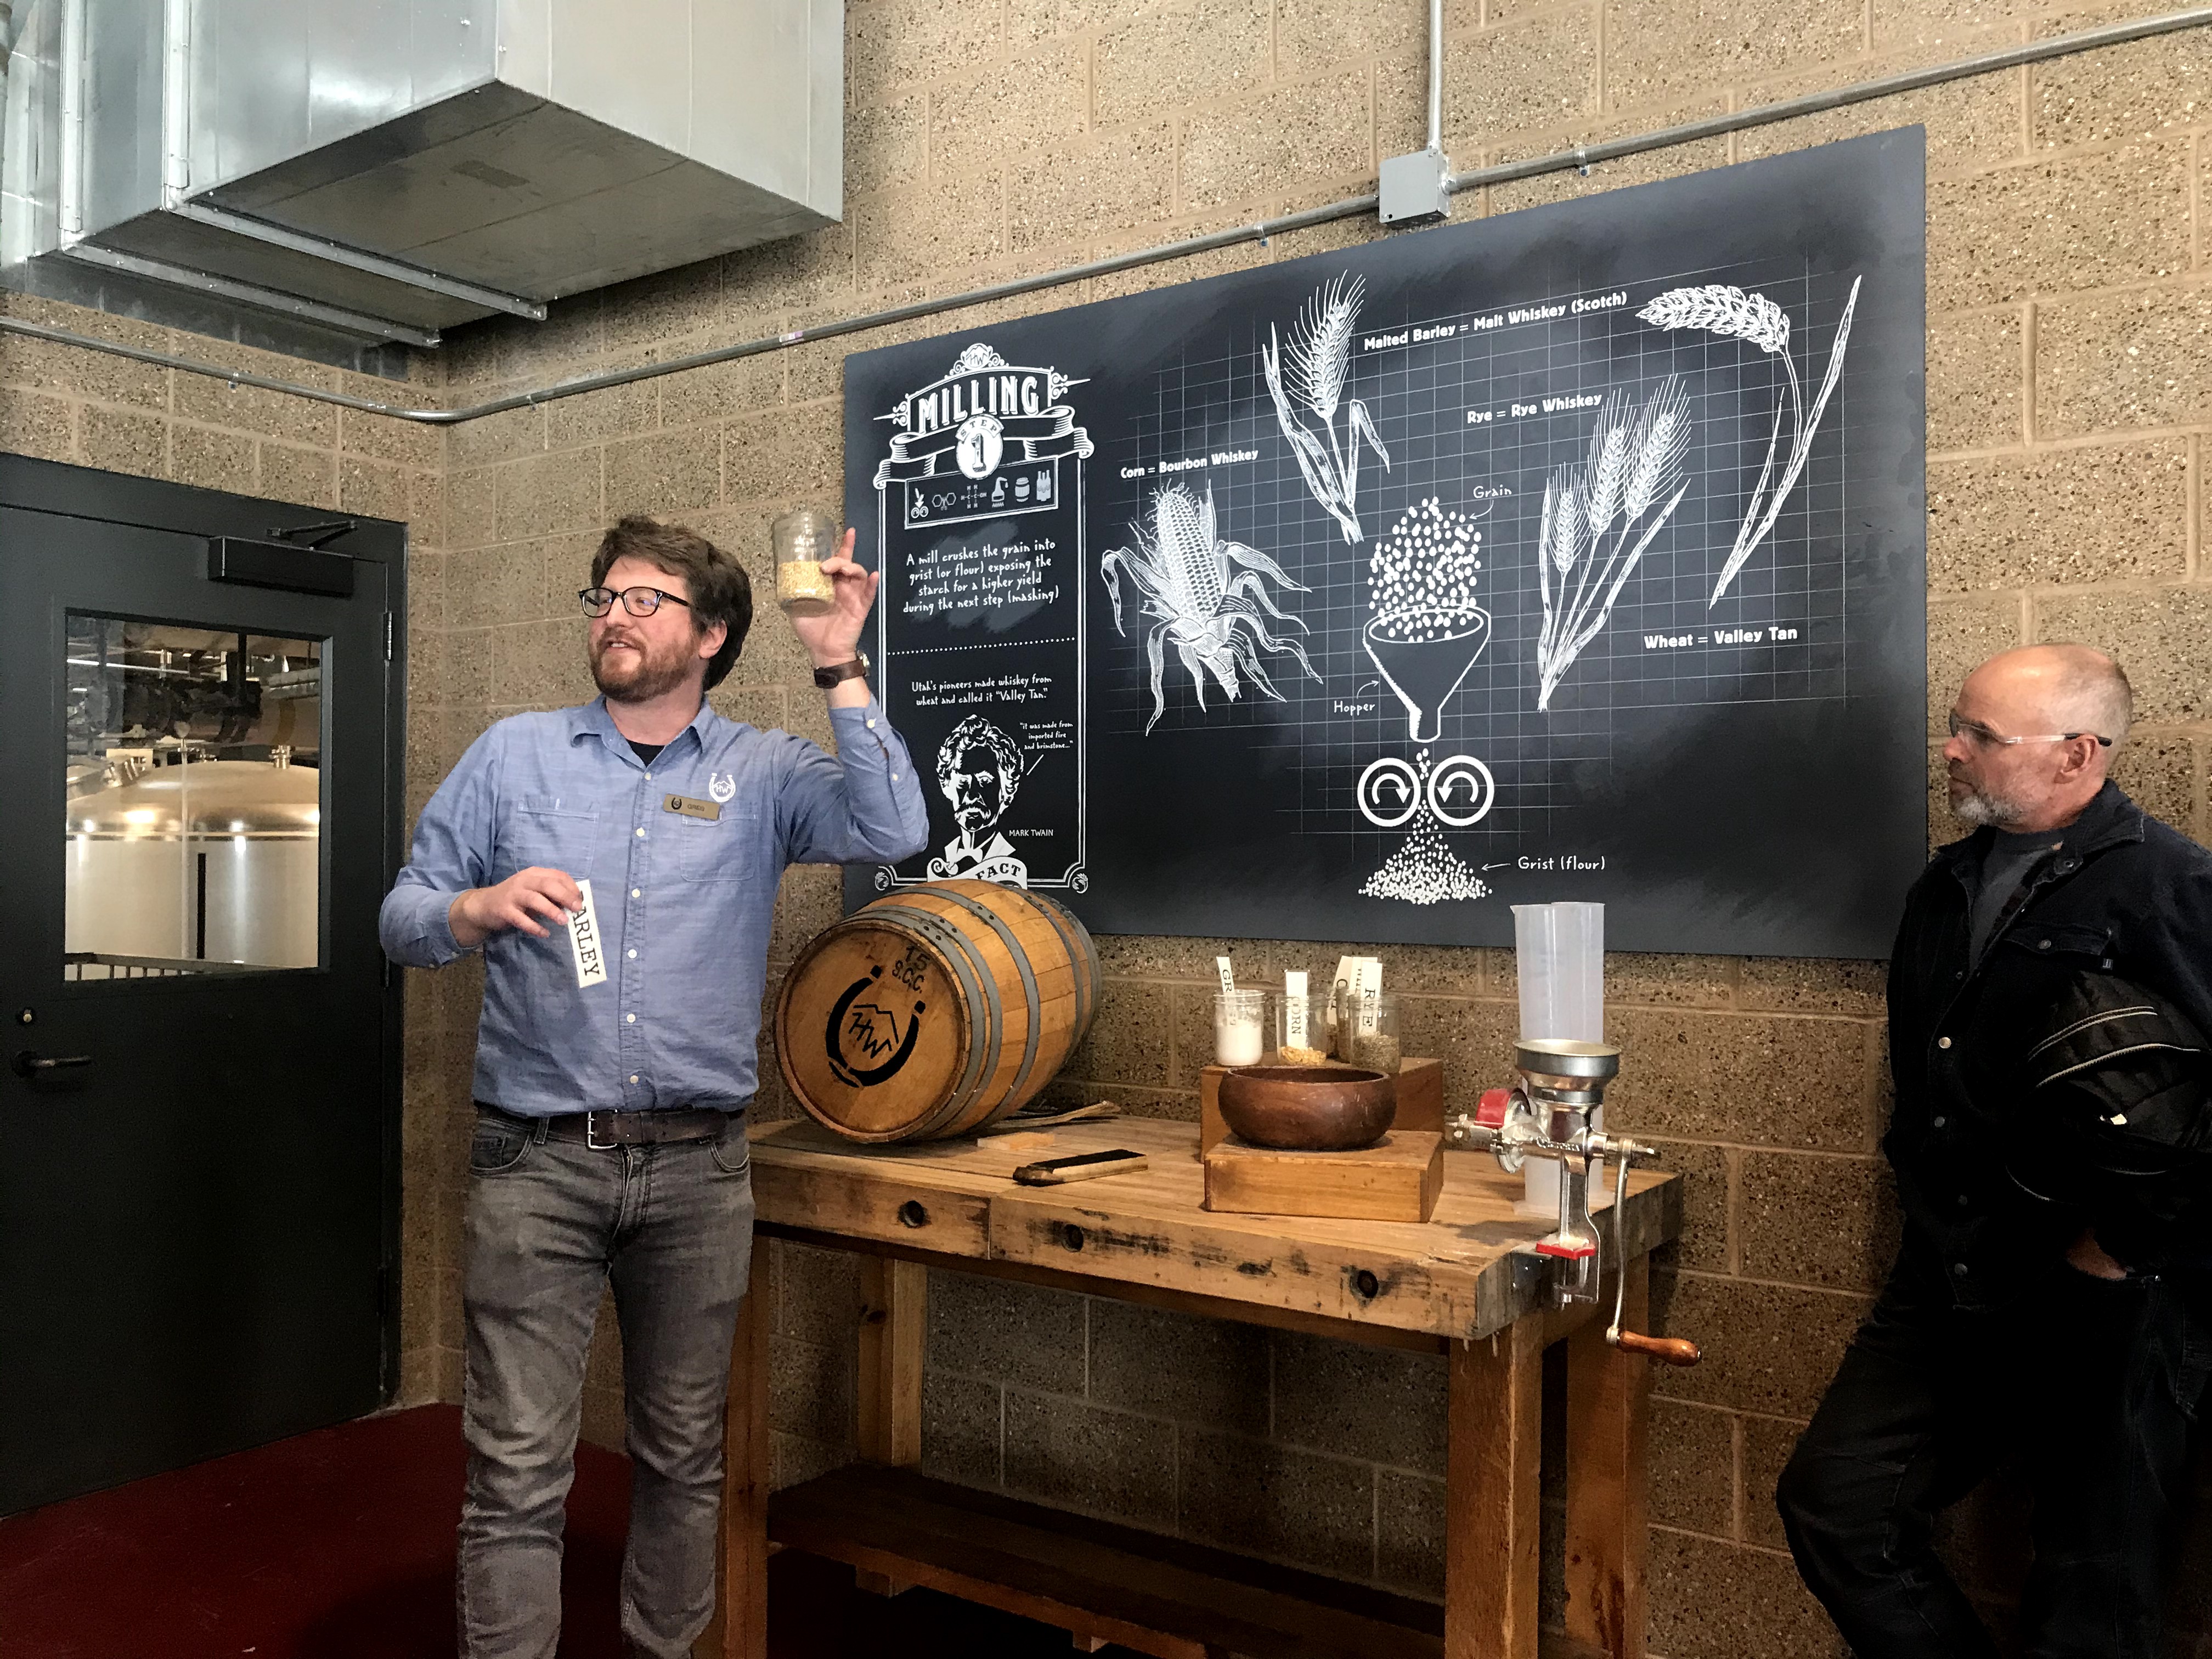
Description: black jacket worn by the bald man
xmin=1882 ymin=783 xmax=2212 ymax=1307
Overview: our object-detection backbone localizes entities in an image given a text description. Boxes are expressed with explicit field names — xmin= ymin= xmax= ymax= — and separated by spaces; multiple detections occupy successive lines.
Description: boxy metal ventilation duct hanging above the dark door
xmin=0 ymin=0 xmax=845 ymax=345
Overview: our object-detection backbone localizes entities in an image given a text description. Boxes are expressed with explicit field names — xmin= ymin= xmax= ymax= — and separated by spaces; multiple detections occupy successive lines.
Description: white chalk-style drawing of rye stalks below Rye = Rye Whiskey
xmin=1535 ymin=374 xmax=1690 ymax=708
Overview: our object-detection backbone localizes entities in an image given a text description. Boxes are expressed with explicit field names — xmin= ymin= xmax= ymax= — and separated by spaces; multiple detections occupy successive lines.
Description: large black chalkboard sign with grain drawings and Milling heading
xmin=845 ymin=128 xmax=1927 ymax=956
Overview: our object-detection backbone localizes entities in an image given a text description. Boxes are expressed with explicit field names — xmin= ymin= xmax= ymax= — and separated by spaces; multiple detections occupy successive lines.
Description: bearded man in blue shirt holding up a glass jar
xmin=381 ymin=517 xmax=929 ymax=1659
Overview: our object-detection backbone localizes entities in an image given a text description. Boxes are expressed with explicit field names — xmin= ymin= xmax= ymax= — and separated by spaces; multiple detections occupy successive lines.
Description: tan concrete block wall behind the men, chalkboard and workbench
xmin=13 ymin=0 xmax=2212 ymax=1659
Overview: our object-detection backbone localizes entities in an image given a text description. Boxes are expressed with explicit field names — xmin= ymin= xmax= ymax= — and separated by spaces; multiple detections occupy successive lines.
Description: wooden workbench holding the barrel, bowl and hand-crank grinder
xmin=708 ymin=1119 xmax=1681 ymax=1659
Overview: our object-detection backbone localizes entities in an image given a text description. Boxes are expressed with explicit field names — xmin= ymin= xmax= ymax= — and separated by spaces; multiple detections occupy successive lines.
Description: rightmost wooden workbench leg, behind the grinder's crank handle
xmin=1566 ymin=1256 xmax=1652 ymax=1659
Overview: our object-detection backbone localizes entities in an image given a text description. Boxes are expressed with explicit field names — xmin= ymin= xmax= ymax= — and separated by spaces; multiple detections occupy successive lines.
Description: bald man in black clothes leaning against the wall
xmin=1776 ymin=646 xmax=2212 ymax=1659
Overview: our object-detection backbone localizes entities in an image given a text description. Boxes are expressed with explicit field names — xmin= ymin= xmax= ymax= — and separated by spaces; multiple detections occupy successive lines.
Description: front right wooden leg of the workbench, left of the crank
xmin=1444 ymin=1314 xmax=1544 ymax=1659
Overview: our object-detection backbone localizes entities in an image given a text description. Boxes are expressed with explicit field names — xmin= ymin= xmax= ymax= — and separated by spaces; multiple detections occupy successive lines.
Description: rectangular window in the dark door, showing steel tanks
xmin=62 ymin=615 xmax=323 ymax=980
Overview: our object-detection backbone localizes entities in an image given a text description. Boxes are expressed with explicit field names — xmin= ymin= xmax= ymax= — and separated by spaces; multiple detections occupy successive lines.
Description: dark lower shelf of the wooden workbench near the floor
xmin=768 ymin=1464 xmax=1599 ymax=1659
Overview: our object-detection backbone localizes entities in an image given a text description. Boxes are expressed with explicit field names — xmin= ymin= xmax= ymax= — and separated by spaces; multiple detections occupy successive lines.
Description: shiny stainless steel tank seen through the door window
xmin=64 ymin=761 xmax=323 ymax=967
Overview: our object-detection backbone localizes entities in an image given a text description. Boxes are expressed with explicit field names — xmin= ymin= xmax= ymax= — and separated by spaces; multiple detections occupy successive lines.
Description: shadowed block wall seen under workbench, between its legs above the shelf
xmin=922 ymin=1274 xmax=1444 ymax=1597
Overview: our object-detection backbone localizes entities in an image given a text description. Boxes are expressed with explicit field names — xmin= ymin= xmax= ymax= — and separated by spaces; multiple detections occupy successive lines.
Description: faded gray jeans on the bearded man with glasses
xmin=458 ymin=1113 xmax=752 ymax=1659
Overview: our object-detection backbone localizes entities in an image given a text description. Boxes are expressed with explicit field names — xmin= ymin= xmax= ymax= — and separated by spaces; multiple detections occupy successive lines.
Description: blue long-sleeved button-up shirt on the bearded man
xmin=378 ymin=697 xmax=929 ymax=1117
